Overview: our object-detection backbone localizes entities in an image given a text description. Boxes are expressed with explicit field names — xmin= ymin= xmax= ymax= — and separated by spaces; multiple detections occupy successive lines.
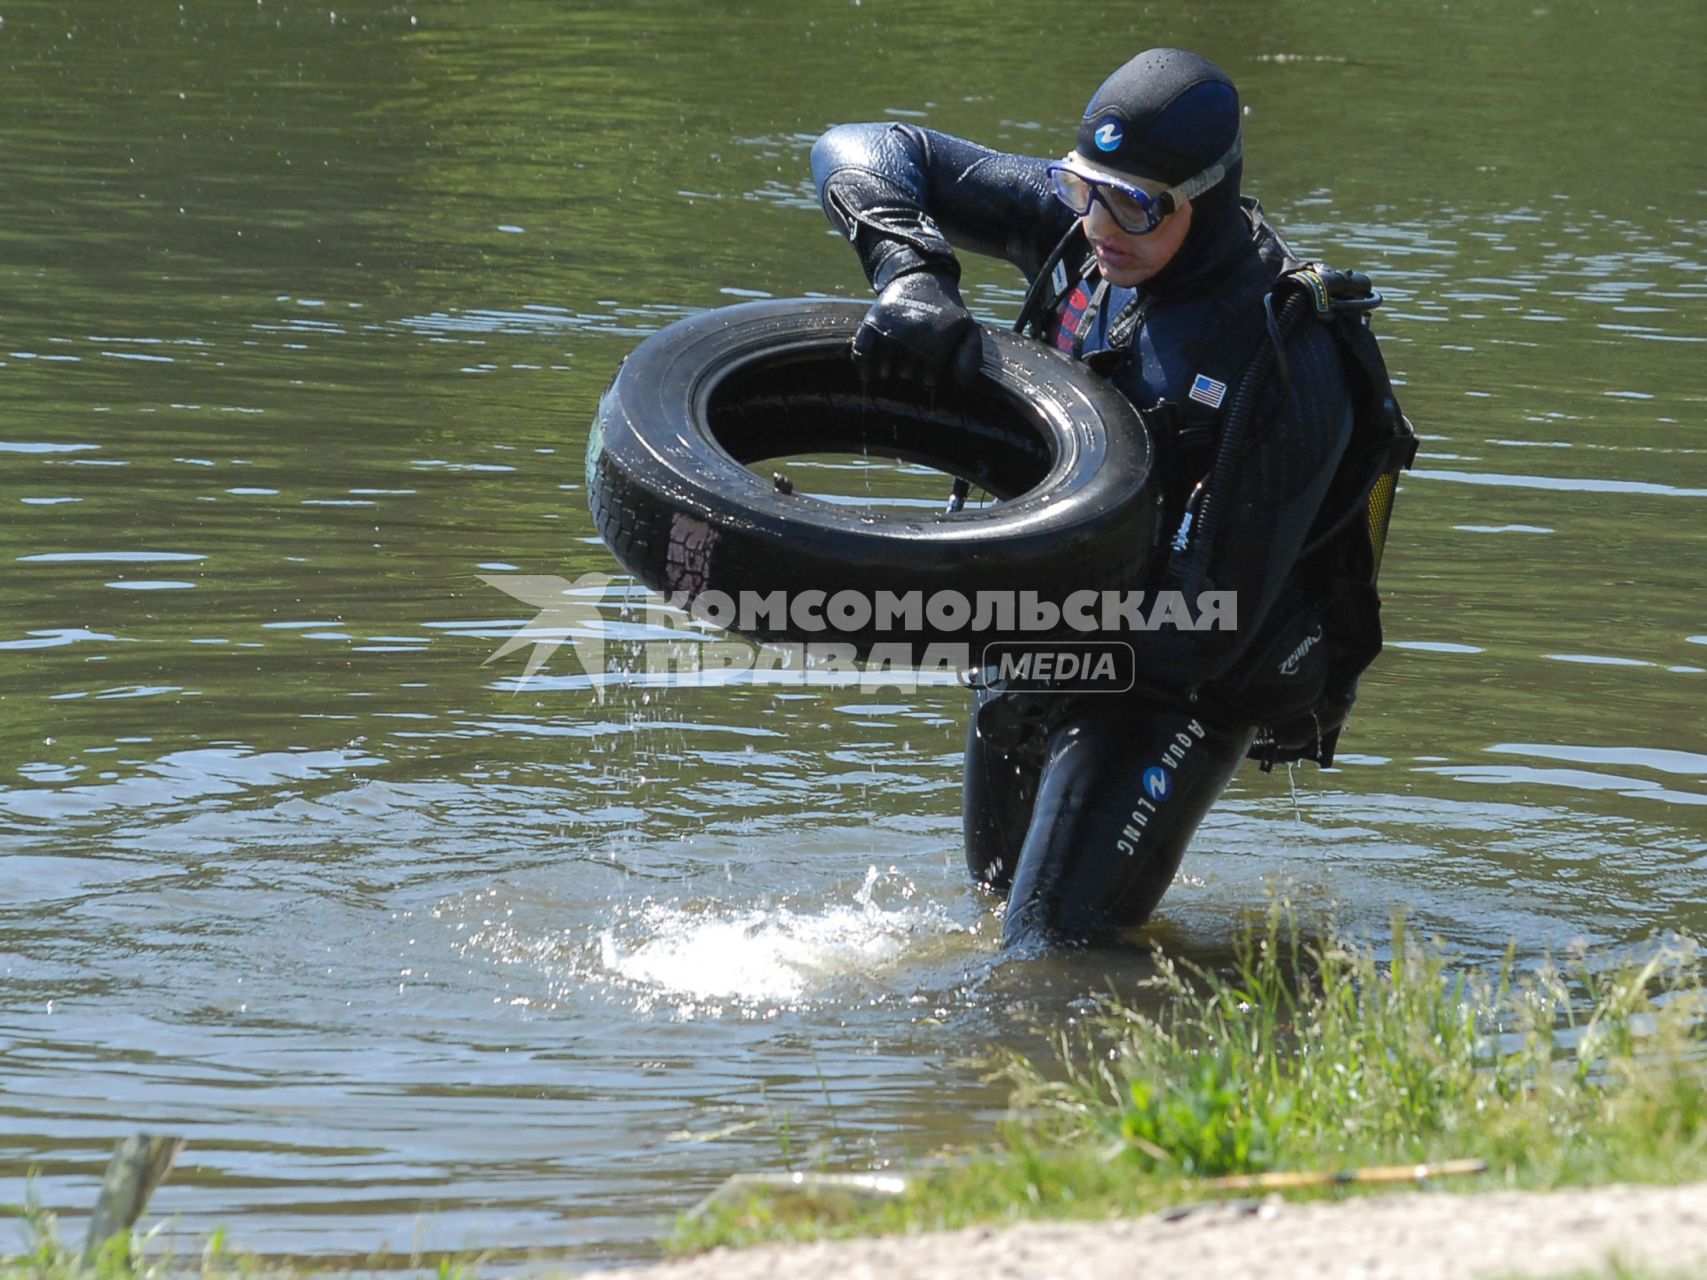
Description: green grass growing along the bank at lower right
xmin=673 ymin=906 xmax=1707 ymax=1251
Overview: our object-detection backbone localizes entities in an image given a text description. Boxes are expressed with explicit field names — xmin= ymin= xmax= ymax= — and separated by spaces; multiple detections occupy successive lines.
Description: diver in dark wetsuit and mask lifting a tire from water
xmin=813 ymin=49 xmax=1367 ymax=945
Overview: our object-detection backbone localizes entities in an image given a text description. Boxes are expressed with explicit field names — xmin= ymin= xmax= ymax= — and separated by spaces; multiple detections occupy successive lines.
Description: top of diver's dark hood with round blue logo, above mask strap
xmin=1077 ymin=49 xmax=1239 ymax=186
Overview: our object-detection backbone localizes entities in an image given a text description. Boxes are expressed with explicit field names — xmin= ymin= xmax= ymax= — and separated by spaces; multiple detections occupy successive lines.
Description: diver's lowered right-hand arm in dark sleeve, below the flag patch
xmin=1137 ymin=321 xmax=1352 ymax=686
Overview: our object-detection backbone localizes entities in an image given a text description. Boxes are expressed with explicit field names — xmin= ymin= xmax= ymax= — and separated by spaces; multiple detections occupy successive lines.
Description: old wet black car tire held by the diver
xmin=587 ymin=299 xmax=1161 ymax=650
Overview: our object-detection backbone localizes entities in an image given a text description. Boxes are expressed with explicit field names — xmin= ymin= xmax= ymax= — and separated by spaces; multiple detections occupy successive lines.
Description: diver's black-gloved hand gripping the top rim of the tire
xmin=854 ymin=271 xmax=983 ymax=387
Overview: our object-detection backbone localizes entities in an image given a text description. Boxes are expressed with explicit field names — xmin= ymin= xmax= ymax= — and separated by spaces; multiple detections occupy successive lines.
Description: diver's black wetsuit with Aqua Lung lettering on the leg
xmin=813 ymin=125 xmax=1352 ymax=944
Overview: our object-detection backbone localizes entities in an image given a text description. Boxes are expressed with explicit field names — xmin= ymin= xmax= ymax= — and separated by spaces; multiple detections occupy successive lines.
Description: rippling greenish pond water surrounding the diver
xmin=0 ymin=0 xmax=1707 ymax=1265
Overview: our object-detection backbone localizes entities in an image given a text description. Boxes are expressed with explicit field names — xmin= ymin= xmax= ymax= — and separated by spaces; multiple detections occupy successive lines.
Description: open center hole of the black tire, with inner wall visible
xmin=705 ymin=345 xmax=1057 ymax=507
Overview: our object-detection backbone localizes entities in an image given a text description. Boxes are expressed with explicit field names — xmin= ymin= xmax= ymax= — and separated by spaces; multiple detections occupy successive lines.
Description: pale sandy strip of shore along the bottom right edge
xmin=621 ymin=1183 xmax=1707 ymax=1280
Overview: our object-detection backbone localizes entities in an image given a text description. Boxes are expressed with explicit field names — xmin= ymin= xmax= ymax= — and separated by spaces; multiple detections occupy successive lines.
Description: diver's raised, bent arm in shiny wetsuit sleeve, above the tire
xmin=813 ymin=125 xmax=1072 ymax=290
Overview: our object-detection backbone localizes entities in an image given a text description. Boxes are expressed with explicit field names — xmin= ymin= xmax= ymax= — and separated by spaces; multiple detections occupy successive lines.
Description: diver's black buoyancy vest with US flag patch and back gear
xmin=1014 ymin=210 xmax=1417 ymax=771
